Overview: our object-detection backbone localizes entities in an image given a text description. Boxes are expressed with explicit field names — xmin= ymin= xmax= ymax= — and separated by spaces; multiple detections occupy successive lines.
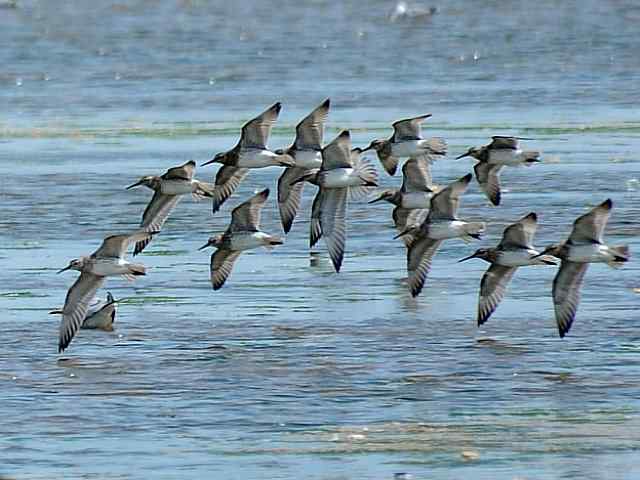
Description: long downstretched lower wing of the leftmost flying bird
xmin=58 ymin=272 xmax=105 ymax=353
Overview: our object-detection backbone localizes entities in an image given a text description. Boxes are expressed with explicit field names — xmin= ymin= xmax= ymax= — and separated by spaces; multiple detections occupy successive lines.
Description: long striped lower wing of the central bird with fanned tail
xmin=320 ymin=188 xmax=348 ymax=272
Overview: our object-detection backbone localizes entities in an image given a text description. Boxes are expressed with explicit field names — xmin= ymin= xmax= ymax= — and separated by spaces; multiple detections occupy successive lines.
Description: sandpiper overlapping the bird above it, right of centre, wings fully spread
xmin=396 ymin=173 xmax=485 ymax=297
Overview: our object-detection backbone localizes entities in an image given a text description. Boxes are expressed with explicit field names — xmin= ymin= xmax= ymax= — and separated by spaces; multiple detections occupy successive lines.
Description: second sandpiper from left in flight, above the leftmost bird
xmin=127 ymin=160 xmax=214 ymax=256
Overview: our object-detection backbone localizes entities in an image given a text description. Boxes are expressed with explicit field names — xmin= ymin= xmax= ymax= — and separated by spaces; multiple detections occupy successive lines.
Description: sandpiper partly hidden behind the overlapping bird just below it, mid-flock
xmin=369 ymin=158 xmax=438 ymax=244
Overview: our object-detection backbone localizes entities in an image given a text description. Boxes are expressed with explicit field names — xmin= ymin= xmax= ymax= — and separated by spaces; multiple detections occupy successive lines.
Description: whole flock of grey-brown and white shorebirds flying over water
xmin=52 ymin=99 xmax=629 ymax=352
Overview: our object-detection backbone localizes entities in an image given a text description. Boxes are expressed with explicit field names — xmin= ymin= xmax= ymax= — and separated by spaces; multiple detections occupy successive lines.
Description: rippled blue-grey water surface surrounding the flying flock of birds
xmin=0 ymin=0 xmax=640 ymax=479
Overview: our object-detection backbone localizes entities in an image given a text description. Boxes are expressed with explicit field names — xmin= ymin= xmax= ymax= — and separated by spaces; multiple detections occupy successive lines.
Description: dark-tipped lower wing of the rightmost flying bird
xmin=553 ymin=260 xmax=589 ymax=338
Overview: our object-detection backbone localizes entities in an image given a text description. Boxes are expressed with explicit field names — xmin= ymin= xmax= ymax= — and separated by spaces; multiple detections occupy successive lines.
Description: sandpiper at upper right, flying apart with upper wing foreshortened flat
xmin=456 ymin=135 xmax=541 ymax=206
